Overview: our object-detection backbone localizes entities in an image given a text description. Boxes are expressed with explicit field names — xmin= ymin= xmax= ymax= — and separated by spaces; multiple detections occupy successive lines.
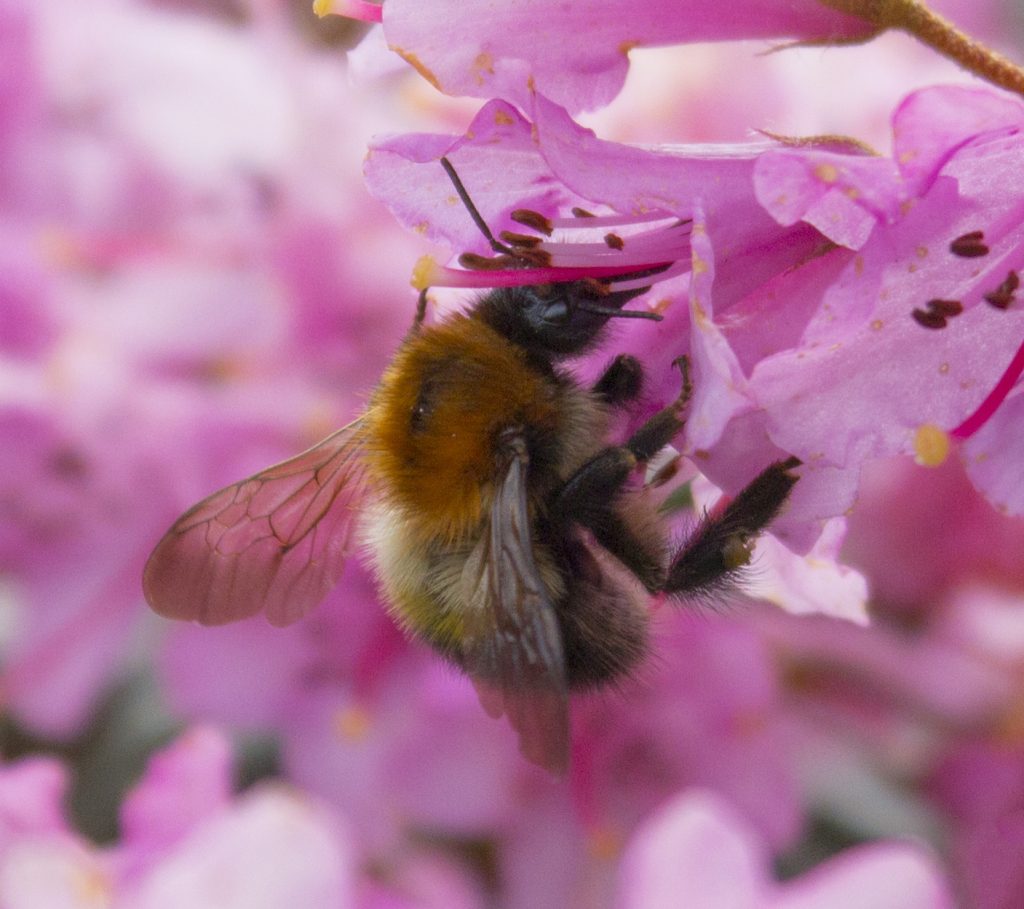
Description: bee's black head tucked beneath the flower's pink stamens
xmin=473 ymin=280 xmax=657 ymax=356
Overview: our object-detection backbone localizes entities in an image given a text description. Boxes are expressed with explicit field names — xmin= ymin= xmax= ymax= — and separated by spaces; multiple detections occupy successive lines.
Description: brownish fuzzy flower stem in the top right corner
xmin=819 ymin=0 xmax=1024 ymax=95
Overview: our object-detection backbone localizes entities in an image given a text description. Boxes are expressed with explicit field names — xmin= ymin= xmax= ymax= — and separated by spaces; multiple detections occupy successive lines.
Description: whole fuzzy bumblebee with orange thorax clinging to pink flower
xmin=143 ymin=160 xmax=799 ymax=773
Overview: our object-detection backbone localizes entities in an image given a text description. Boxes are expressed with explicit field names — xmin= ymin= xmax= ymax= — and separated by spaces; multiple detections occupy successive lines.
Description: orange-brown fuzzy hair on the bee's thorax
xmin=367 ymin=315 xmax=562 ymax=540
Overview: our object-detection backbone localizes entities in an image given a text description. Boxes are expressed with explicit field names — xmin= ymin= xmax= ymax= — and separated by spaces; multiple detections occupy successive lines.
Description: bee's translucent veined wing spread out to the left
xmin=142 ymin=420 xmax=367 ymax=625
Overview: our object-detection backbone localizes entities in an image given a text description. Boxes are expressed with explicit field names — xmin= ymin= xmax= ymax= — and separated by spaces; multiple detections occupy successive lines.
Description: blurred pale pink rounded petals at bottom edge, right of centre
xmin=616 ymin=790 xmax=953 ymax=909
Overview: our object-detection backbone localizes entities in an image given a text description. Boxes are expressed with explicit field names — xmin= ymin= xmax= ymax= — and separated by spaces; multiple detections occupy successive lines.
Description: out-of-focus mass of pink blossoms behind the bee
xmin=0 ymin=0 xmax=1024 ymax=909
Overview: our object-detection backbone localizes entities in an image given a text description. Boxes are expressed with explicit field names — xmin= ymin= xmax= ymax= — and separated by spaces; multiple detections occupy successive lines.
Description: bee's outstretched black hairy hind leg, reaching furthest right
xmin=663 ymin=458 xmax=800 ymax=597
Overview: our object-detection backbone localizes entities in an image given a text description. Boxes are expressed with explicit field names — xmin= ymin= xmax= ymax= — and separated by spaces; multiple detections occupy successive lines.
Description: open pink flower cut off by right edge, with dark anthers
xmin=751 ymin=88 xmax=1024 ymax=512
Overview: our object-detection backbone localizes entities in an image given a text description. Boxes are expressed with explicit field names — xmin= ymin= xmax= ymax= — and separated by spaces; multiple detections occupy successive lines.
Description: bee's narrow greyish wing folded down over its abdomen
xmin=463 ymin=436 xmax=569 ymax=774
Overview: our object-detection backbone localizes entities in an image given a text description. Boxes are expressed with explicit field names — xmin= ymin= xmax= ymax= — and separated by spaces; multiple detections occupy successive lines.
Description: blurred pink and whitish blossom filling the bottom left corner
xmin=0 ymin=727 xmax=480 ymax=909
